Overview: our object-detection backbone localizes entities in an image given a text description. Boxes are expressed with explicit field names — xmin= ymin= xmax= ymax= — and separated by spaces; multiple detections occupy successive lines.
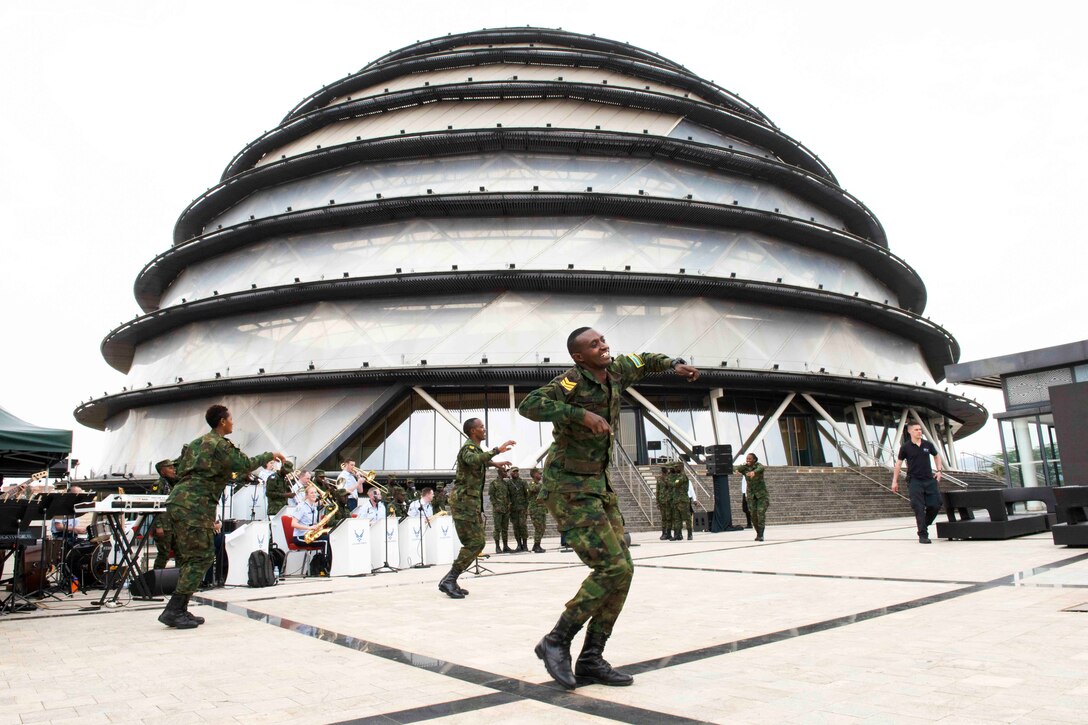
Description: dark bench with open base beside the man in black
xmin=937 ymin=487 xmax=1056 ymax=540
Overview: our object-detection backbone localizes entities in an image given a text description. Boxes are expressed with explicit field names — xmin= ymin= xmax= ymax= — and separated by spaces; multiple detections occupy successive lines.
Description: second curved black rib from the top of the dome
xmin=281 ymin=48 xmax=776 ymax=127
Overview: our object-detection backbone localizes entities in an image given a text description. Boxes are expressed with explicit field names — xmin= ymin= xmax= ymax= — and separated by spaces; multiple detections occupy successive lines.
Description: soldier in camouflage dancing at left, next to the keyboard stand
xmin=159 ymin=405 xmax=287 ymax=629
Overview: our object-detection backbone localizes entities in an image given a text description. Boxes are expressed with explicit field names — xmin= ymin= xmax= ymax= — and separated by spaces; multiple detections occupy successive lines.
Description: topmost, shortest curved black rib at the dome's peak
xmin=367 ymin=27 xmax=684 ymax=70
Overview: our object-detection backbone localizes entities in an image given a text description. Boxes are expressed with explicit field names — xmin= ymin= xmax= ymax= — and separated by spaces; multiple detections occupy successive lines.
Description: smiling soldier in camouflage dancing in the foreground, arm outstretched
xmin=518 ymin=328 xmax=698 ymax=689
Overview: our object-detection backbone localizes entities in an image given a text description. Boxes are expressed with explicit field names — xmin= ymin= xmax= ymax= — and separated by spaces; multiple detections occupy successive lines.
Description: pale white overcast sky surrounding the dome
xmin=0 ymin=0 xmax=1088 ymax=474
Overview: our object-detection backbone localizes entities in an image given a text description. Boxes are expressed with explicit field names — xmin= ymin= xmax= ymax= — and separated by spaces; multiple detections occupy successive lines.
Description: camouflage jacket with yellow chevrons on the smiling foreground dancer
xmin=518 ymin=353 xmax=673 ymax=493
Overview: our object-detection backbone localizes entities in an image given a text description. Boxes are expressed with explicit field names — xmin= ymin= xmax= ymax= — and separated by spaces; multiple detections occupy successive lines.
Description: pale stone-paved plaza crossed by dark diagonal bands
xmin=6 ymin=518 xmax=1088 ymax=725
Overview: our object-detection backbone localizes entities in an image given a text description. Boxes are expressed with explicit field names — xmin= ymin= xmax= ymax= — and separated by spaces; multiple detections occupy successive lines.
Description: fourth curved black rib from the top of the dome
xmin=174 ymin=128 xmax=888 ymax=247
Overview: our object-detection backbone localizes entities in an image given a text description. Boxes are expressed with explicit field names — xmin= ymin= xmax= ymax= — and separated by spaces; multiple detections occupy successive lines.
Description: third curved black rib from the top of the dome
xmin=220 ymin=81 xmax=838 ymax=183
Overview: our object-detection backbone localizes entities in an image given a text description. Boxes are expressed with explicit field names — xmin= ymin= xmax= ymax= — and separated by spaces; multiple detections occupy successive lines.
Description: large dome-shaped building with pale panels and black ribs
xmin=75 ymin=28 xmax=986 ymax=474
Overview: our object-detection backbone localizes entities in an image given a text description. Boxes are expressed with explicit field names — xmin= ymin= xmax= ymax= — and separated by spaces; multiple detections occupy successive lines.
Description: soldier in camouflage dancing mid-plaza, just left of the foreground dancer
xmin=438 ymin=418 xmax=514 ymax=599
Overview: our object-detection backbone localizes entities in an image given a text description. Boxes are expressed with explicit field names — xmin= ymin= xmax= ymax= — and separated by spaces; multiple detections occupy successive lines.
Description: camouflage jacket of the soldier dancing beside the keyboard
xmin=166 ymin=431 xmax=272 ymax=528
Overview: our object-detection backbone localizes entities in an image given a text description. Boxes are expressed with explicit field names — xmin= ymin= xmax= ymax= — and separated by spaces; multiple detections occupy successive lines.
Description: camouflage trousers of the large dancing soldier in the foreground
xmin=545 ymin=491 xmax=634 ymax=637
